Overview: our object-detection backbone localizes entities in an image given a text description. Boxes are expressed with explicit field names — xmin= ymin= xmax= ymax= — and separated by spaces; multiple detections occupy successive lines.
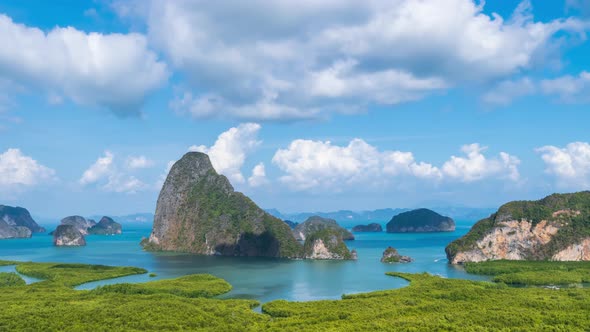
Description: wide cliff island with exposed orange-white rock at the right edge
xmin=446 ymin=191 xmax=590 ymax=264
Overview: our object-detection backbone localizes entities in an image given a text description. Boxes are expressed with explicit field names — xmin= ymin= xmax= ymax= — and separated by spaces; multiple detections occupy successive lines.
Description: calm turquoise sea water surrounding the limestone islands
xmin=0 ymin=221 xmax=486 ymax=303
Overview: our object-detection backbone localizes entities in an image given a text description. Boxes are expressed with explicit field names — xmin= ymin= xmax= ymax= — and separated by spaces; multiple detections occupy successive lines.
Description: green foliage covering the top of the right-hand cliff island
xmin=446 ymin=191 xmax=590 ymax=257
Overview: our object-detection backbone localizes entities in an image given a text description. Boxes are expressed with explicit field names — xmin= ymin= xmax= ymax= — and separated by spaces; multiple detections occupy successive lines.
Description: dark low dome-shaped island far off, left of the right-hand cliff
xmin=387 ymin=209 xmax=455 ymax=233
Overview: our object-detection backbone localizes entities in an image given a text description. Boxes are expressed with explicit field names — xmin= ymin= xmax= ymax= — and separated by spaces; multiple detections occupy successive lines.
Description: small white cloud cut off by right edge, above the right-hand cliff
xmin=536 ymin=142 xmax=590 ymax=189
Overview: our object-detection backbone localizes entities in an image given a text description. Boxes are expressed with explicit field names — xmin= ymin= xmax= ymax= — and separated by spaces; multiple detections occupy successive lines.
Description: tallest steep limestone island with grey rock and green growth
xmin=142 ymin=152 xmax=302 ymax=257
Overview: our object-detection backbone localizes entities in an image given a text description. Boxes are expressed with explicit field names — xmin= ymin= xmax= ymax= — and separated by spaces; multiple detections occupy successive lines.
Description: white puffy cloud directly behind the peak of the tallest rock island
xmin=189 ymin=123 xmax=260 ymax=183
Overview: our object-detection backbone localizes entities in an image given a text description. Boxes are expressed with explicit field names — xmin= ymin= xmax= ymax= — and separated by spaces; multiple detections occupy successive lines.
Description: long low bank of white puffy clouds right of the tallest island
xmin=272 ymin=138 xmax=520 ymax=190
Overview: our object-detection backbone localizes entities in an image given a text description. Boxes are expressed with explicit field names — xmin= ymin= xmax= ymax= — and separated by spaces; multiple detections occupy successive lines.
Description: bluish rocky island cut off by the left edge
xmin=0 ymin=205 xmax=45 ymax=239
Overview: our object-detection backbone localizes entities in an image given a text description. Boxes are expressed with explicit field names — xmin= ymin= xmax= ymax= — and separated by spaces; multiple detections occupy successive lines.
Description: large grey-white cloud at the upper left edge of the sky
xmin=0 ymin=14 xmax=169 ymax=116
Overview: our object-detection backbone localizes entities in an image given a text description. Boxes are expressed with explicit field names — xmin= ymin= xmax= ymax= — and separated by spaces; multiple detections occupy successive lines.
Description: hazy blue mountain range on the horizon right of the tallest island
xmin=266 ymin=207 xmax=496 ymax=226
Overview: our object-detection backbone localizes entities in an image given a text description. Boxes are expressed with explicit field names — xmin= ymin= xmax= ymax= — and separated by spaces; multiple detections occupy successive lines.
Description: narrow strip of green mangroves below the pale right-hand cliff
xmin=465 ymin=260 xmax=590 ymax=286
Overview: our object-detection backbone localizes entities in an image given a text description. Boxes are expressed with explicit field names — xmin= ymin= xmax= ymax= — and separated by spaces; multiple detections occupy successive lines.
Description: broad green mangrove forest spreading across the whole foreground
xmin=0 ymin=262 xmax=590 ymax=331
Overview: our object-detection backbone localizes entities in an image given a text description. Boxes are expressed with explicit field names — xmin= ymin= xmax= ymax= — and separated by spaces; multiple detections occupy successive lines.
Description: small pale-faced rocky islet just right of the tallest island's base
xmin=303 ymin=228 xmax=357 ymax=260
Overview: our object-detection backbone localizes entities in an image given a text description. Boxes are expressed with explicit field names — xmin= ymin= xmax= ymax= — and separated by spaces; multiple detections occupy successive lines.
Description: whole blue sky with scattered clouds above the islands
xmin=0 ymin=0 xmax=590 ymax=218
